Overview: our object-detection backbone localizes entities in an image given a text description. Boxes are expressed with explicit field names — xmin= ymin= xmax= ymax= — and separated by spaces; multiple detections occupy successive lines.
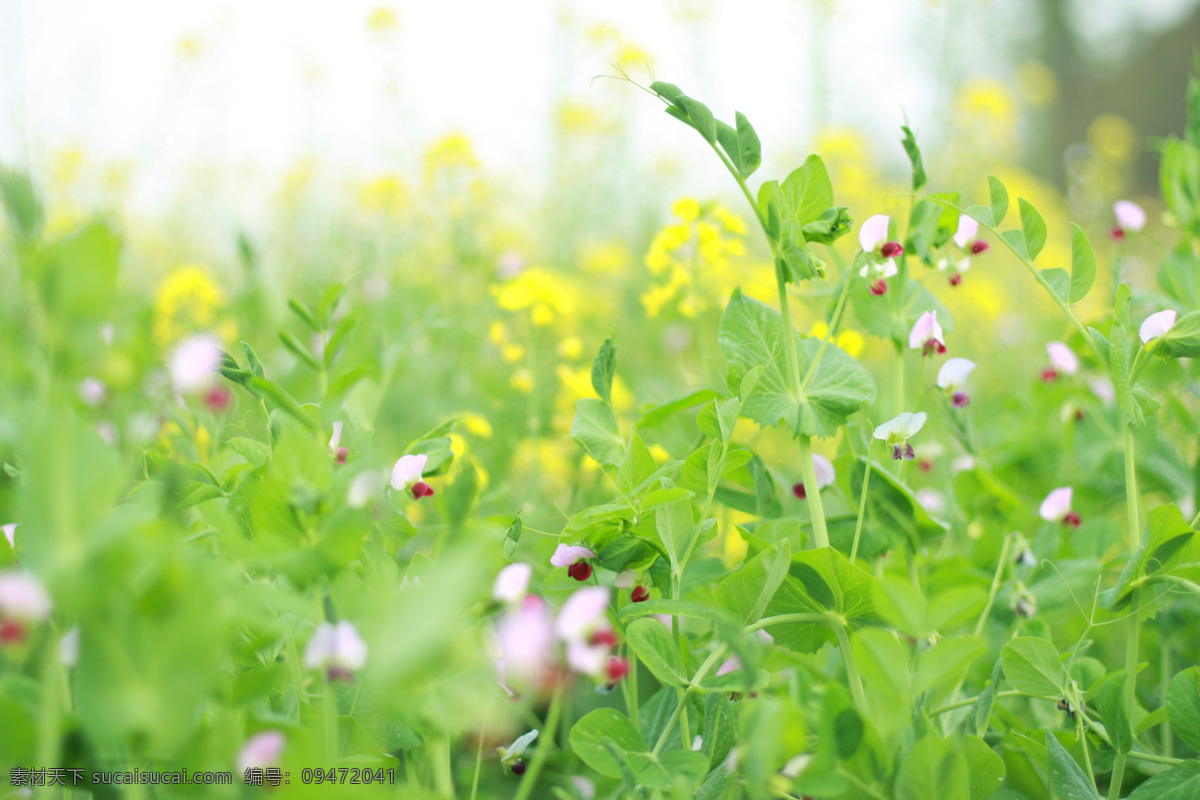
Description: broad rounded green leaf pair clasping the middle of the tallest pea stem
xmin=718 ymin=290 xmax=875 ymax=437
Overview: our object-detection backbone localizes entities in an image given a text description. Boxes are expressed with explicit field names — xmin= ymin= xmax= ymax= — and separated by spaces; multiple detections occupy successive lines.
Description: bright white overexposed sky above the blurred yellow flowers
xmin=0 ymin=0 xmax=1194 ymax=209
